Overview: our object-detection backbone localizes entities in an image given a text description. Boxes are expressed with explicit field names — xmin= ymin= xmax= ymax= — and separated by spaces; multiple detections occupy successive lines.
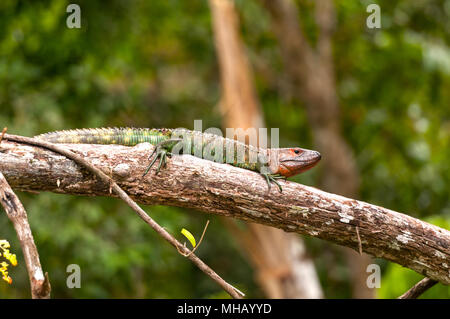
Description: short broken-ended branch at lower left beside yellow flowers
xmin=0 ymin=172 xmax=51 ymax=299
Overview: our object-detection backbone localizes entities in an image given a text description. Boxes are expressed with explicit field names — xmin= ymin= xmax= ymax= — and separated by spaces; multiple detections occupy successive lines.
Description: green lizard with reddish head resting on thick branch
xmin=34 ymin=128 xmax=321 ymax=192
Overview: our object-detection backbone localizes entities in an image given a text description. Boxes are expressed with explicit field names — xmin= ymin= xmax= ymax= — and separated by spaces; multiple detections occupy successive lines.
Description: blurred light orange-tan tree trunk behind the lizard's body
xmin=209 ymin=0 xmax=323 ymax=298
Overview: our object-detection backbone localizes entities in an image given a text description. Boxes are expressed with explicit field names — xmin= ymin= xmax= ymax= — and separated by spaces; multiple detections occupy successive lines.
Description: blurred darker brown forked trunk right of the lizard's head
xmin=263 ymin=0 xmax=375 ymax=298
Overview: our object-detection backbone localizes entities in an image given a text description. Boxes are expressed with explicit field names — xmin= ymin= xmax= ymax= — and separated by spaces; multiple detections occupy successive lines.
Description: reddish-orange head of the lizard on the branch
xmin=277 ymin=147 xmax=322 ymax=177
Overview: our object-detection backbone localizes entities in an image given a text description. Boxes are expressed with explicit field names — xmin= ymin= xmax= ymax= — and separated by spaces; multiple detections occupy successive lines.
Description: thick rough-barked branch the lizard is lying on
xmin=0 ymin=139 xmax=450 ymax=284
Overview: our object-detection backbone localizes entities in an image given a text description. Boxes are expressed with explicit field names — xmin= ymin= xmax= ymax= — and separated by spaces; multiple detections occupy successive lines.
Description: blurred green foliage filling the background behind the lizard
xmin=0 ymin=0 xmax=450 ymax=298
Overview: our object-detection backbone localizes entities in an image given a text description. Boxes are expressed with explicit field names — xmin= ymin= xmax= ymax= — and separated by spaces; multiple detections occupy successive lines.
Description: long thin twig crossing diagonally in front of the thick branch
xmin=4 ymin=134 xmax=244 ymax=299
